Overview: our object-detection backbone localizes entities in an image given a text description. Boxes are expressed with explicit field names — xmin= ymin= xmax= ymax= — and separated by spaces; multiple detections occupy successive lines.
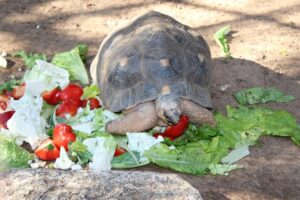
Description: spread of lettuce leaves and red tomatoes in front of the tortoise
xmin=0 ymin=45 xmax=300 ymax=175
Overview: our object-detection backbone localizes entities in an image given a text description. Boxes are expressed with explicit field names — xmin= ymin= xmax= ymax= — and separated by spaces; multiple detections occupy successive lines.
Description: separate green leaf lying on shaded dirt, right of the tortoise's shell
xmin=233 ymin=87 xmax=295 ymax=105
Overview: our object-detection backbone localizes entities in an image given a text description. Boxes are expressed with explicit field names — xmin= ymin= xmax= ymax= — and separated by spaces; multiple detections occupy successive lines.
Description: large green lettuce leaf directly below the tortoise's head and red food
xmin=144 ymin=137 xmax=228 ymax=175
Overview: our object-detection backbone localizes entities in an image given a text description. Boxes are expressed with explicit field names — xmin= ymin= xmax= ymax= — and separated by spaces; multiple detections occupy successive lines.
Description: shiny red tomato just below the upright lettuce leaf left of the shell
xmin=60 ymin=83 xmax=83 ymax=106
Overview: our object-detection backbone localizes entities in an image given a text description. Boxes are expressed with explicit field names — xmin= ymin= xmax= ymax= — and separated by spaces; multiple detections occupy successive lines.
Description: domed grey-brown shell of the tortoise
xmin=91 ymin=11 xmax=212 ymax=112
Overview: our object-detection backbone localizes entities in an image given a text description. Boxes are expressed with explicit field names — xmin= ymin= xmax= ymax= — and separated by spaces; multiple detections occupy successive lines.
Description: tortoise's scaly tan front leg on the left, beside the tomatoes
xmin=105 ymin=102 xmax=158 ymax=135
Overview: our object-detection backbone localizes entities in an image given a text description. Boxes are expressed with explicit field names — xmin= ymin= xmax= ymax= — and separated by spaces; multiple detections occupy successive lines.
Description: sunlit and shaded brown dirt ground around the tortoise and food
xmin=0 ymin=0 xmax=300 ymax=199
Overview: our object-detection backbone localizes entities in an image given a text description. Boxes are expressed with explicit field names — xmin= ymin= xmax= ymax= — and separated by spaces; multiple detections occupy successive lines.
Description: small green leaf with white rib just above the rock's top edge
xmin=111 ymin=151 xmax=149 ymax=169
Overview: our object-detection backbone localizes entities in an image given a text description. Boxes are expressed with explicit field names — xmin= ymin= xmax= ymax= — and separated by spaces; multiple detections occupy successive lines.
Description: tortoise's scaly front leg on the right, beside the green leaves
xmin=181 ymin=99 xmax=216 ymax=126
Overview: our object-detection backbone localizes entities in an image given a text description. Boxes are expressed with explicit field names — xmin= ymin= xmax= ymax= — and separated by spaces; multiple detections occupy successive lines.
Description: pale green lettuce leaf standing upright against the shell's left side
xmin=52 ymin=45 xmax=89 ymax=85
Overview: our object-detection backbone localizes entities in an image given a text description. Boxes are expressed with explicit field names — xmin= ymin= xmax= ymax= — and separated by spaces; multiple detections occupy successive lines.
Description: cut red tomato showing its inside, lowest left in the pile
xmin=34 ymin=139 xmax=59 ymax=161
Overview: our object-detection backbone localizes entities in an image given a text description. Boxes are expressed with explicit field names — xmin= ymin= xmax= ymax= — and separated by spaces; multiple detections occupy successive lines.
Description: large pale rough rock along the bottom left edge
xmin=0 ymin=169 xmax=202 ymax=200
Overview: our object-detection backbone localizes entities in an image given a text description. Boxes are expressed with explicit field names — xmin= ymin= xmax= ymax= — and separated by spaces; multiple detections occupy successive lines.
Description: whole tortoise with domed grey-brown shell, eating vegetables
xmin=90 ymin=11 xmax=215 ymax=134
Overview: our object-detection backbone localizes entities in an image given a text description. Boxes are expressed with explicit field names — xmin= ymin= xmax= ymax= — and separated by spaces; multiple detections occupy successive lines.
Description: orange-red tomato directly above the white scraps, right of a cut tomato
xmin=53 ymin=124 xmax=76 ymax=151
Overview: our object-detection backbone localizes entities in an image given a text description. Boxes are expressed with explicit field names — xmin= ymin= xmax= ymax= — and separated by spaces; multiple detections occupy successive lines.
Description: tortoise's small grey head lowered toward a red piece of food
xmin=155 ymin=93 xmax=182 ymax=125
